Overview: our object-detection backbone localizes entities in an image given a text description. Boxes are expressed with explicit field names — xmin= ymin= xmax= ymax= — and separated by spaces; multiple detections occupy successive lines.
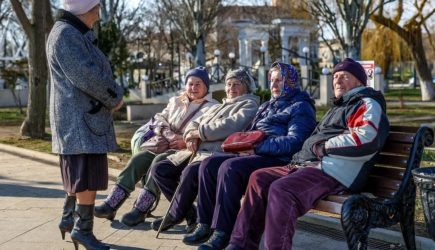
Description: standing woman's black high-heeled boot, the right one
xmin=71 ymin=204 xmax=110 ymax=250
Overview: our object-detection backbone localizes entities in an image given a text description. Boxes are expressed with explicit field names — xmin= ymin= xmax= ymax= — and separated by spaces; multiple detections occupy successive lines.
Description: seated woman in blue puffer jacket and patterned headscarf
xmin=183 ymin=63 xmax=316 ymax=249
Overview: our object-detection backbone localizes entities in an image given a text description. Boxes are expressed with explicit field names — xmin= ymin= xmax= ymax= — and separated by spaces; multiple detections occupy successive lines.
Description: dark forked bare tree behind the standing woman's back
xmin=10 ymin=0 xmax=53 ymax=138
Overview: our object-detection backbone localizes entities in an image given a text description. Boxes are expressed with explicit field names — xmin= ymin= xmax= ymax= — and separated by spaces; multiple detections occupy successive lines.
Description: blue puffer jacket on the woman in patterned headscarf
xmin=248 ymin=88 xmax=316 ymax=161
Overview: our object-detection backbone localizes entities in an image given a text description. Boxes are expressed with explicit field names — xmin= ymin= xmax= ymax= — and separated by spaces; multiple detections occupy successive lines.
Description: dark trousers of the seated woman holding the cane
xmin=151 ymin=160 xmax=200 ymax=220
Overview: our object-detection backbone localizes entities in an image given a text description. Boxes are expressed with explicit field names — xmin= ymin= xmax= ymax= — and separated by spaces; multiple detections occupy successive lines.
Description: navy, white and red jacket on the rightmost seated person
xmin=292 ymin=87 xmax=390 ymax=192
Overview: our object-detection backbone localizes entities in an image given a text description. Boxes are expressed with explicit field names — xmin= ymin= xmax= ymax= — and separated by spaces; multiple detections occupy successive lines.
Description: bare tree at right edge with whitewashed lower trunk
xmin=371 ymin=0 xmax=435 ymax=101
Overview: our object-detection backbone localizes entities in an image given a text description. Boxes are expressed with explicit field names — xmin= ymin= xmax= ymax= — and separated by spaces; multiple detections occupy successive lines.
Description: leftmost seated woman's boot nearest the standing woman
xmin=95 ymin=185 xmax=130 ymax=220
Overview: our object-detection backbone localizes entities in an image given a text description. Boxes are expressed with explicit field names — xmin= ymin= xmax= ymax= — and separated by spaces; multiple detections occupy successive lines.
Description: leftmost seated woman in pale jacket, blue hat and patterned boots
xmin=94 ymin=67 xmax=218 ymax=226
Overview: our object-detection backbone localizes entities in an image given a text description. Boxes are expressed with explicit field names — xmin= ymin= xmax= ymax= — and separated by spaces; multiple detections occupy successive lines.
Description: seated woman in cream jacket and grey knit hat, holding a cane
xmin=151 ymin=70 xmax=259 ymax=231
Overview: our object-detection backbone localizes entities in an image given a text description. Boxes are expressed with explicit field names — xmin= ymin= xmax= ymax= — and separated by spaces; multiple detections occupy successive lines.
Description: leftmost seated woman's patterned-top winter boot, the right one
xmin=121 ymin=188 xmax=156 ymax=227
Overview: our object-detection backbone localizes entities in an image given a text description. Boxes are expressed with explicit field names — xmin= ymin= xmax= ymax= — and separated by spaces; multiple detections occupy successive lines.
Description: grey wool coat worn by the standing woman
xmin=46 ymin=12 xmax=123 ymax=155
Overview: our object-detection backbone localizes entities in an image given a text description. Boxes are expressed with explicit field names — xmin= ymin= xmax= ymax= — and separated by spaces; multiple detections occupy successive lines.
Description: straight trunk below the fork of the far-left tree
xmin=20 ymin=24 xmax=48 ymax=138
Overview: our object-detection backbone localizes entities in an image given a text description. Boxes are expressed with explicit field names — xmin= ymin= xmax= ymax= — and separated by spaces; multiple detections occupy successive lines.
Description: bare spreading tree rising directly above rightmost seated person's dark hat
xmin=306 ymin=0 xmax=393 ymax=59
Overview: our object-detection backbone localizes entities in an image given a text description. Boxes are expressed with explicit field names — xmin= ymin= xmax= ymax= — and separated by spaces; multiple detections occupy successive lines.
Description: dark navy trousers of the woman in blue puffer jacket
xmin=198 ymin=154 xmax=285 ymax=234
